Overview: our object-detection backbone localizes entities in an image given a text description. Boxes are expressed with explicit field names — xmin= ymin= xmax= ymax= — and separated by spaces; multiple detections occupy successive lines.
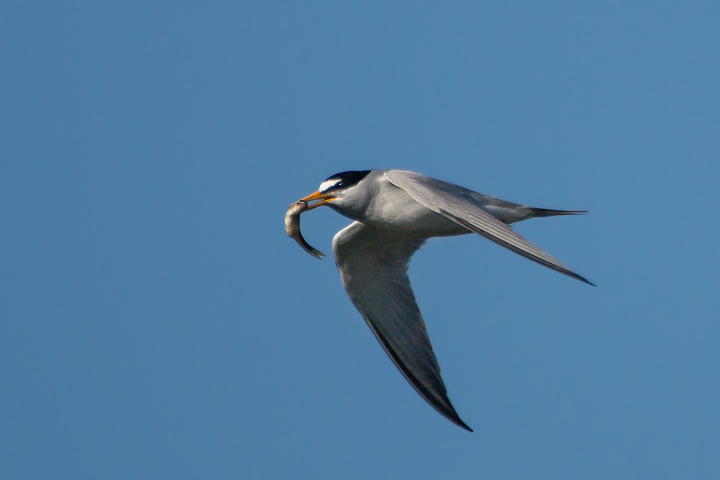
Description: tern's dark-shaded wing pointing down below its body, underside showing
xmin=333 ymin=222 xmax=472 ymax=432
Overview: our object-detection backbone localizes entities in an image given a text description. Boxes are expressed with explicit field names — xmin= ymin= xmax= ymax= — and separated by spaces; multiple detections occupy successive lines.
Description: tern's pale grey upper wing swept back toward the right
xmin=385 ymin=170 xmax=593 ymax=285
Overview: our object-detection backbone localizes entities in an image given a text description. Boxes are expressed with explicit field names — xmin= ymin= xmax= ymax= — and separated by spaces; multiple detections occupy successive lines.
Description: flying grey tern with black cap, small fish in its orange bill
xmin=286 ymin=170 xmax=593 ymax=432
